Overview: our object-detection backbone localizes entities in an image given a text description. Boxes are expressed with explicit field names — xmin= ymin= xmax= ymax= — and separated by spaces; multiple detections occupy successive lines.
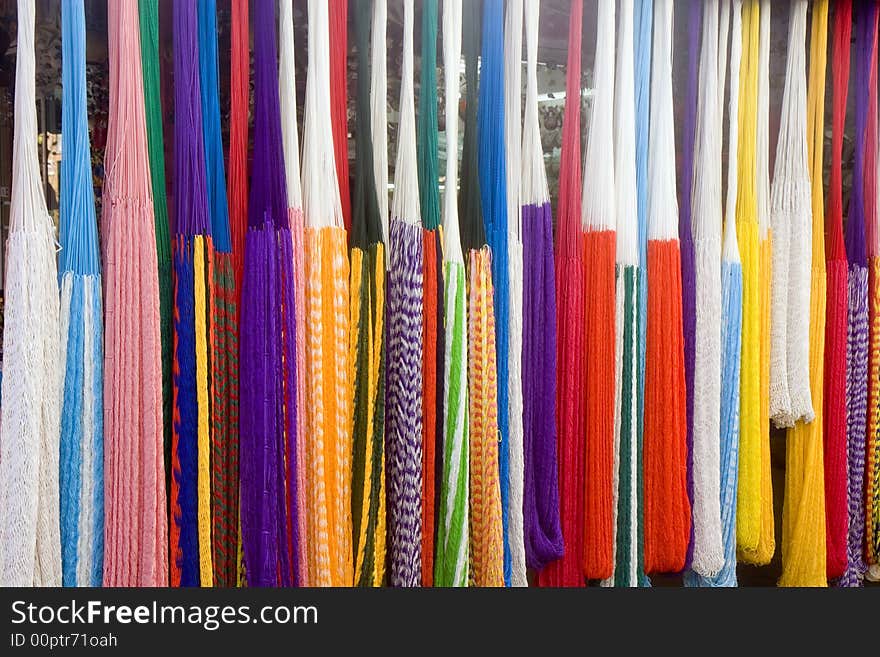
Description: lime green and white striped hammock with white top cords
xmin=434 ymin=0 xmax=469 ymax=587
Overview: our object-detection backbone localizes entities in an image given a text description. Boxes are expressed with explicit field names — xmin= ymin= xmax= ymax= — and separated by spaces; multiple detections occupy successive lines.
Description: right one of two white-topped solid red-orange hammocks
xmin=644 ymin=0 xmax=691 ymax=572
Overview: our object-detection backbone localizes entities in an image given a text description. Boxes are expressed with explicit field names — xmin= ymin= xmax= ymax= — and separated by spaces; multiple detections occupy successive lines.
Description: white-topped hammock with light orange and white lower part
xmin=301 ymin=0 xmax=354 ymax=586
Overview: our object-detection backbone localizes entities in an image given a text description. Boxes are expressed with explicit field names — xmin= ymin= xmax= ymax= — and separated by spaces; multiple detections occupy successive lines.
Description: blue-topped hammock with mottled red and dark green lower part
xmin=198 ymin=0 xmax=239 ymax=587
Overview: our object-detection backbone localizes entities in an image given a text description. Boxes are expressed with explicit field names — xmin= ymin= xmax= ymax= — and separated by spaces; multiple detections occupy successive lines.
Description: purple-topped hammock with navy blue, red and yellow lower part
xmin=171 ymin=2 xmax=214 ymax=586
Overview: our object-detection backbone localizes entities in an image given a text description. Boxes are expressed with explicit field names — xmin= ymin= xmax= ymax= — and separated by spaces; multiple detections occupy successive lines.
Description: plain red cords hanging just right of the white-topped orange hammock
xmin=330 ymin=0 xmax=351 ymax=231
